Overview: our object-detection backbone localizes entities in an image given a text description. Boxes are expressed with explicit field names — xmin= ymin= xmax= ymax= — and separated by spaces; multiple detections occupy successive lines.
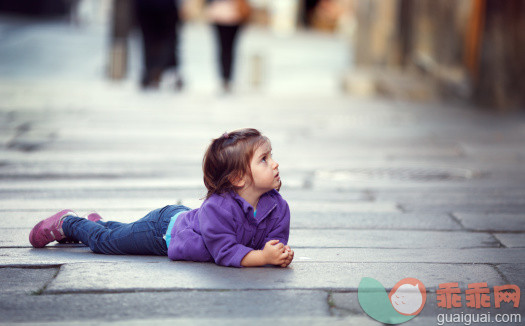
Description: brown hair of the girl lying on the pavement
xmin=202 ymin=128 xmax=270 ymax=199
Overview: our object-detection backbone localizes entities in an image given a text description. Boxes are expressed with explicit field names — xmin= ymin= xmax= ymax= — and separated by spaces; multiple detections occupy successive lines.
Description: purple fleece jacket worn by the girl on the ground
xmin=168 ymin=190 xmax=290 ymax=267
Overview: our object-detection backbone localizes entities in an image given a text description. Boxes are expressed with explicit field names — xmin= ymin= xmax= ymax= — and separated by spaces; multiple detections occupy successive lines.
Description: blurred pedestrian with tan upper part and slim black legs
xmin=207 ymin=0 xmax=251 ymax=92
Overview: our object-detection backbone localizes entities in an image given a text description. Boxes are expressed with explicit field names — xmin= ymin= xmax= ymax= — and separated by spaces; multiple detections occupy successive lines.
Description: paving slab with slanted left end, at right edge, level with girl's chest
xmin=454 ymin=213 xmax=525 ymax=232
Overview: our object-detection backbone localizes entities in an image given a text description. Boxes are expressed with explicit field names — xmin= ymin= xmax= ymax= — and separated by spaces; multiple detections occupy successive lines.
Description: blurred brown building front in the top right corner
xmin=346 ymin=0 xmax=525 ymax=110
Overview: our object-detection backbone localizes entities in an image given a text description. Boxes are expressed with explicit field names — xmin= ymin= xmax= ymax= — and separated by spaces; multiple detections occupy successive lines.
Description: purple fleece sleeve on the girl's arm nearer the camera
xmin=198 ymin=204 xmax=253 ymax=267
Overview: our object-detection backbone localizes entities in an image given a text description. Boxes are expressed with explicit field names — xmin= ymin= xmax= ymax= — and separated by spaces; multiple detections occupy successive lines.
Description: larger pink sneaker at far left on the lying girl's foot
xmin=29 ymin=209 xmax=77 ymax=248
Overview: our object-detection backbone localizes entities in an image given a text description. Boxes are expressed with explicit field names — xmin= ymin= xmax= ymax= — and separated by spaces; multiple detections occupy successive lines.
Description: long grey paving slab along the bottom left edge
xmin=0 ymin=290 xmax=329 ymax=324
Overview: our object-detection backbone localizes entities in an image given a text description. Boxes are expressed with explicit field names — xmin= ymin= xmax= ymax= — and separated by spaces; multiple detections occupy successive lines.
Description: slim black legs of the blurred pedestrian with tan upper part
xmin=214 ymin=24 xmax=241 ymax=92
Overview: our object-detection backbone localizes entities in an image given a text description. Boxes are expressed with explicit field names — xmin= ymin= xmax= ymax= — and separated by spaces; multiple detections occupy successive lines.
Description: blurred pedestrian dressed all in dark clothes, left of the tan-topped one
xmin=135 ymin=0 xmax=183 ymax=89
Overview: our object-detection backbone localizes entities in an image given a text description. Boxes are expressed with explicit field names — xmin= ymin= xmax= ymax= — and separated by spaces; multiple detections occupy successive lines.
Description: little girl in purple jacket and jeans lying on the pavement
xmin=29 ymin=129 xmax=294 ymax=267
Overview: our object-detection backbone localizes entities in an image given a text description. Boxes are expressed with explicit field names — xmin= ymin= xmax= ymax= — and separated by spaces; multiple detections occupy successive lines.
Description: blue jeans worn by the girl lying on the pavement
xmin=62 ymin=205 xmax=189 ymax=256
